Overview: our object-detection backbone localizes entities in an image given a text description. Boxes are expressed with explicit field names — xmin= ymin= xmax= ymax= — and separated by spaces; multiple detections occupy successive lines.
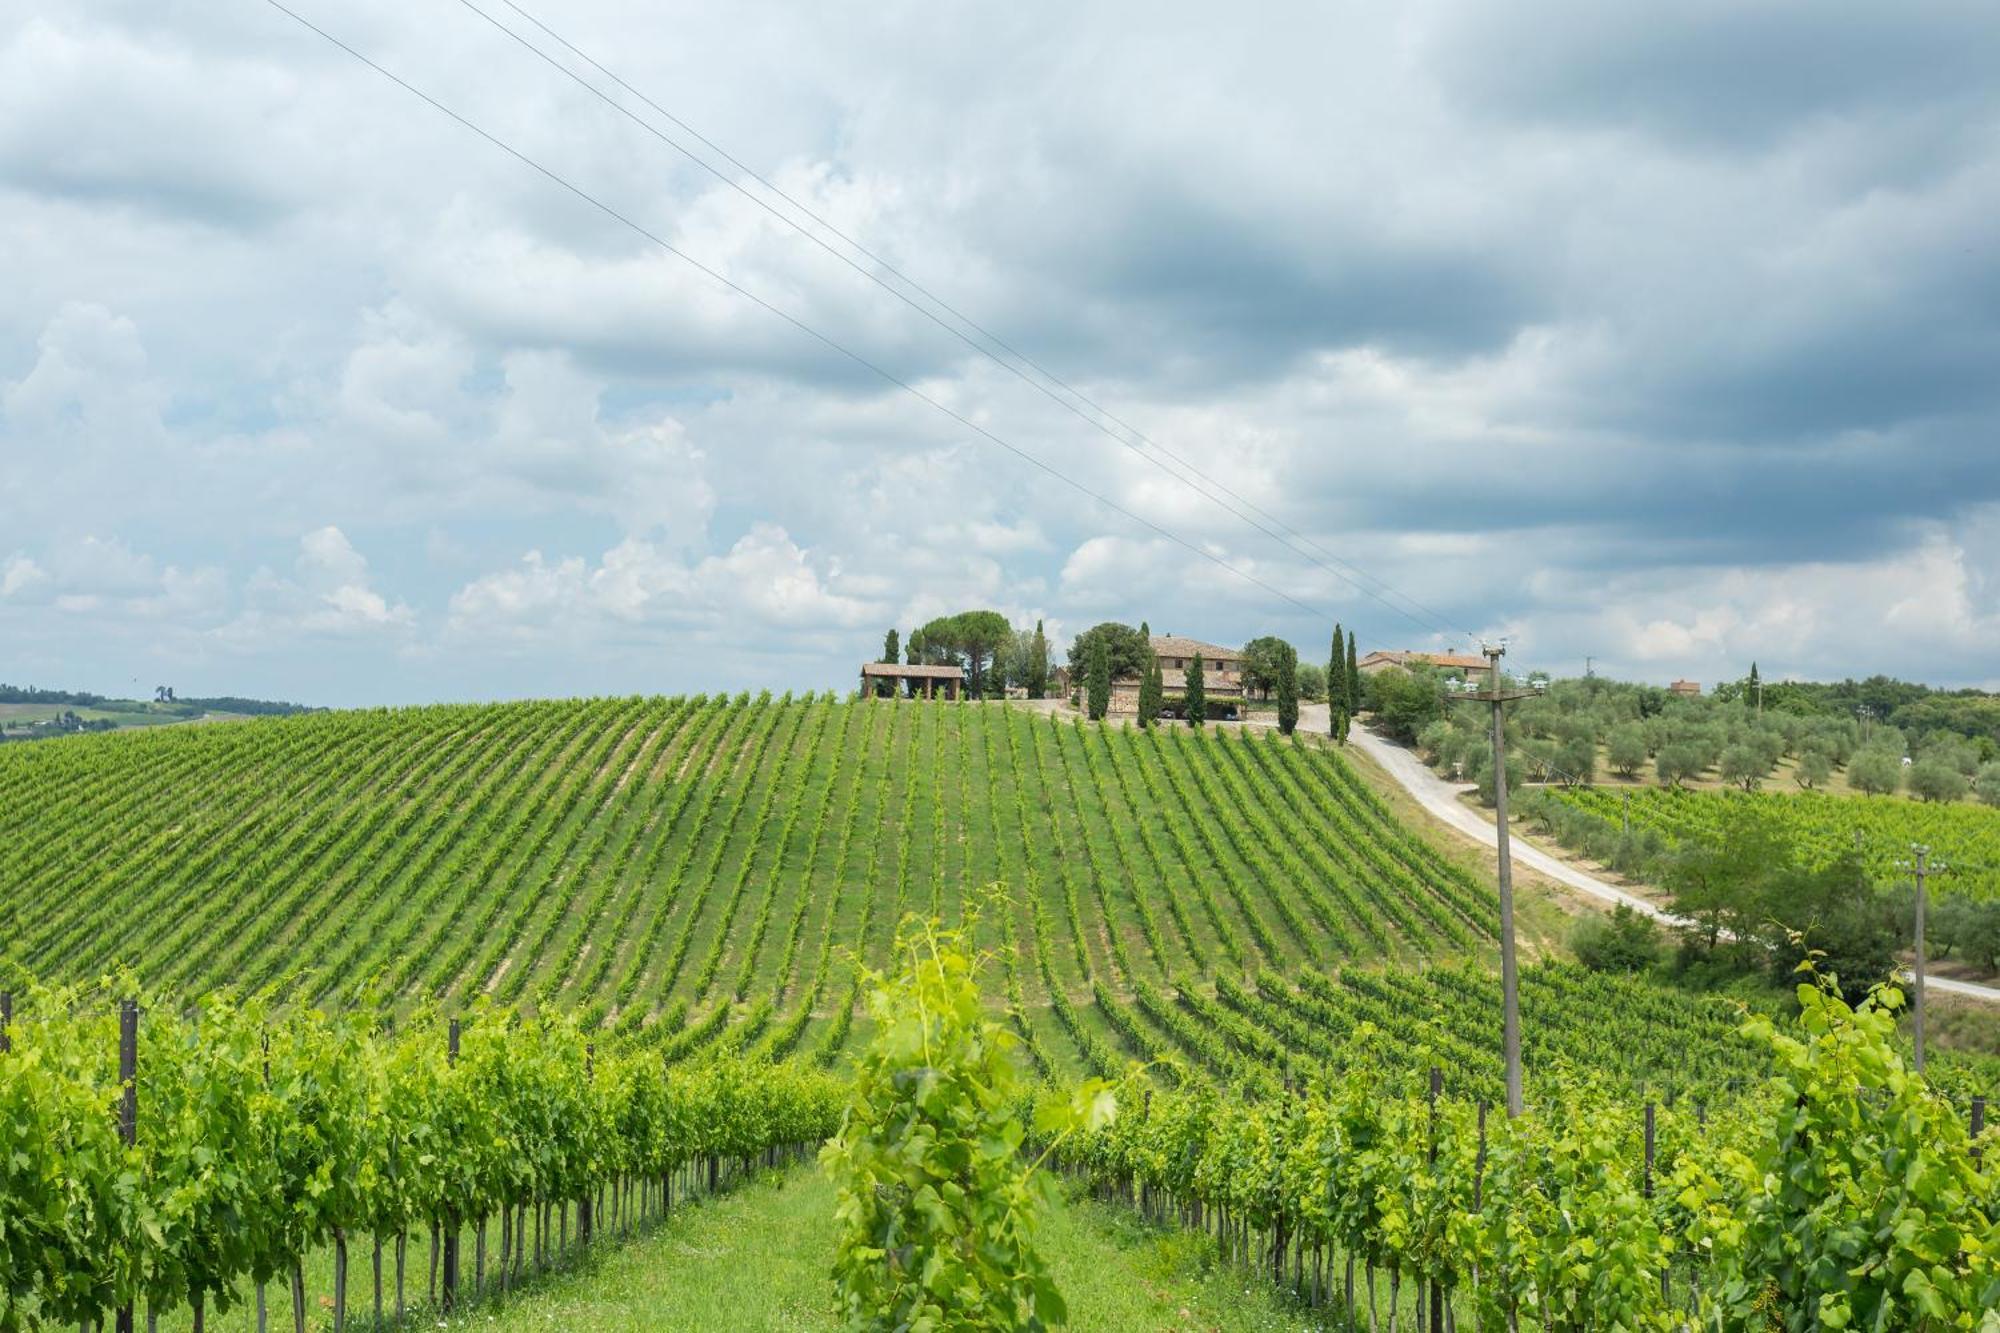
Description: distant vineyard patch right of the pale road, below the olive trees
xmin=1542 ymin=787 xmax=2000 ymax=901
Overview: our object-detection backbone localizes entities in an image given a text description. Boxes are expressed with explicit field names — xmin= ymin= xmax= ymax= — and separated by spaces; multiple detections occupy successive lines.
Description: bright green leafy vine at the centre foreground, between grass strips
xmin=820 ymin=925 xmax=1110 ymax=1331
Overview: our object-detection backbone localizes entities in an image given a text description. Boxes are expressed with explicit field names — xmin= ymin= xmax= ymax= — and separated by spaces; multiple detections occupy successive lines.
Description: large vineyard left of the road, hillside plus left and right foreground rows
xmin=0 ymin=697 xmax=2000 ymax=1329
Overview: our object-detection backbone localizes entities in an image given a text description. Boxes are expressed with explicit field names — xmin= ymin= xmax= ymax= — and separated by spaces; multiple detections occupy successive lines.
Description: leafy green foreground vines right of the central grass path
xmin=1060 ymin=979 xmax=2000 ymax=1333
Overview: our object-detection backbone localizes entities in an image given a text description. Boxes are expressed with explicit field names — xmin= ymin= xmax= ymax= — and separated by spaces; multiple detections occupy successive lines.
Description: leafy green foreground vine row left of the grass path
xmin=0 ymin=993 xmax=840 ymax=1329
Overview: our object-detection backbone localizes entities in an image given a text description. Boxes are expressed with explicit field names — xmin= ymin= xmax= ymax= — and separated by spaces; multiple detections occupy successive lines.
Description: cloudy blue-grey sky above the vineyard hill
xmin=0 ymin=0 xmax=2000 ymax=705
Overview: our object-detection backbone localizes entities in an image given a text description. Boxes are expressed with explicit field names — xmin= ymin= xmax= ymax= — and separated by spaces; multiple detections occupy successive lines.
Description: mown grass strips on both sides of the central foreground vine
xmin=438 ymin=1169 xmax=1324 ymax=1333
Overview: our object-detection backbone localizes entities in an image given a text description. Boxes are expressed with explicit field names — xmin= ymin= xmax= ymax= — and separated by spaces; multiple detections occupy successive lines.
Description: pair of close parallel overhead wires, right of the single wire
xmin=458 ymin=0 xmax=1470 ymax=638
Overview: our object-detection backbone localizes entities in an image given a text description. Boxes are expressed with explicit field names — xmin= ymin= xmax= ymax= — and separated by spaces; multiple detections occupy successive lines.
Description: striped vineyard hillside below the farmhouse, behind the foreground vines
xmin=0 ymin=697 xmax=1792 ymax=1087
